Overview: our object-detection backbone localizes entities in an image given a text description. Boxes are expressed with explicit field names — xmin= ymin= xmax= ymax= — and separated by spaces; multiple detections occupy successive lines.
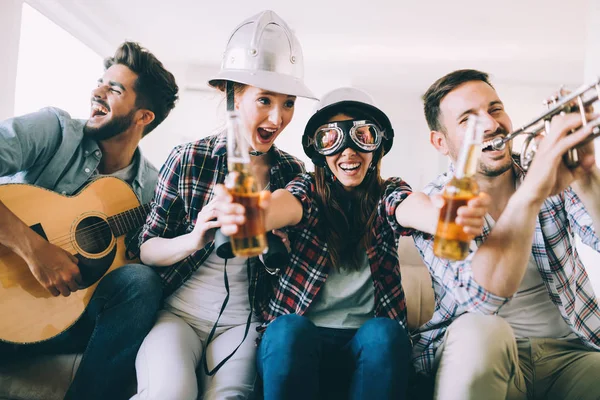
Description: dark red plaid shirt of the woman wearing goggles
xmin=264 ymin=174 xmax=412 ymax=329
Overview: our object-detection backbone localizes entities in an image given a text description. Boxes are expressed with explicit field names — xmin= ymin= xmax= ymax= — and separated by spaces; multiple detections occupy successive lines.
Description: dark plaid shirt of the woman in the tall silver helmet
xmin=140 ymin=132 xmax=305 ymax=304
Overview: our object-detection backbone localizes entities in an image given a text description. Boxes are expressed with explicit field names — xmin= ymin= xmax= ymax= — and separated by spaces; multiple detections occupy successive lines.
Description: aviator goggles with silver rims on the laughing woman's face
xmin=305 ymin=120 xmax=385 ymax=156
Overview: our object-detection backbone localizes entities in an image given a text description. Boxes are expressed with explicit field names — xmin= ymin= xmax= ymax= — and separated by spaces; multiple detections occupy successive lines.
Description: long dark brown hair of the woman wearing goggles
xmin=314 ymin=141 xmax=383 ymax=271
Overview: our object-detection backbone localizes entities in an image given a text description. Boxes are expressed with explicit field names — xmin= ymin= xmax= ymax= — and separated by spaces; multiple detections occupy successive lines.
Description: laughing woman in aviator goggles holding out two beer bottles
xmin=215 ymin=88 xmax=487 ymax=400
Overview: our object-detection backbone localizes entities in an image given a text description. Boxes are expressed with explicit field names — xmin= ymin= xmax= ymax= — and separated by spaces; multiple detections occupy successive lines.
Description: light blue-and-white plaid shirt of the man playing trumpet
xmin=413 ymin=157 xmax=600 ymax=374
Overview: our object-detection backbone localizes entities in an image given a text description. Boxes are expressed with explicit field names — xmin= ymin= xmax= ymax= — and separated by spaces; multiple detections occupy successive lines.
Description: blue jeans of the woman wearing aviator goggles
xmin=257 ymin=314 xmax=411 ymax=400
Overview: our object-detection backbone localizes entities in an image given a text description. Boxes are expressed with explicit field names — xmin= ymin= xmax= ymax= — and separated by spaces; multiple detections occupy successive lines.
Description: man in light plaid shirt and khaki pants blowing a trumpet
xmin=413 ymin=70 xmax=600 ymax=399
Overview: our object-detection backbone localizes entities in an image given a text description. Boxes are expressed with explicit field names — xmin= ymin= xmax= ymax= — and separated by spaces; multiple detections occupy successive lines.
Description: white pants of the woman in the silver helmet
xmin=132 ymin=310 xmax=258 ymax=400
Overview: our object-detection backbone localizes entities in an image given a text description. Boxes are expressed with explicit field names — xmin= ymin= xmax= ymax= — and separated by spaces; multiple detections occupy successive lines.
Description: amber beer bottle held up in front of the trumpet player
xmin=433 ymin=115 xmax=483 ymax=261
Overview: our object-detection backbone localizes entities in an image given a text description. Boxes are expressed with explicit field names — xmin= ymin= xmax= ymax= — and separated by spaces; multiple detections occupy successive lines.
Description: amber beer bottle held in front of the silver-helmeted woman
xmin=225 ymin=111 xmax=267 ymax=257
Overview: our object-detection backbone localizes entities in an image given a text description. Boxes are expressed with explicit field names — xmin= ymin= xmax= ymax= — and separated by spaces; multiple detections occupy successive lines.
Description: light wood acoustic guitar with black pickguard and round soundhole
xmin=0 ymin=177 xmax=150 ymax=344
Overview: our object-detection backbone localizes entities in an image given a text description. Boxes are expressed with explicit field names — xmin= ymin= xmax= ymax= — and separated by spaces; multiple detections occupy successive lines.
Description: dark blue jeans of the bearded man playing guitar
xmin=0 ymin=264 xmax=163 ymax=400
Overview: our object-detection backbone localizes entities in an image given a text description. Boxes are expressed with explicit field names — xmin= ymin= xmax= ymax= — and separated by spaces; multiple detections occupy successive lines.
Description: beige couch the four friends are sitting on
xmin=0 ymin=238 xmax=434 ymax=400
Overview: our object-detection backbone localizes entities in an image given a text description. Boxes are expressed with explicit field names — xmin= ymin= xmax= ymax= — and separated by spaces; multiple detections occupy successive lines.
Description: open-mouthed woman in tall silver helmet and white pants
xmin=135 ymin=11 xmax=314 ymax=400
